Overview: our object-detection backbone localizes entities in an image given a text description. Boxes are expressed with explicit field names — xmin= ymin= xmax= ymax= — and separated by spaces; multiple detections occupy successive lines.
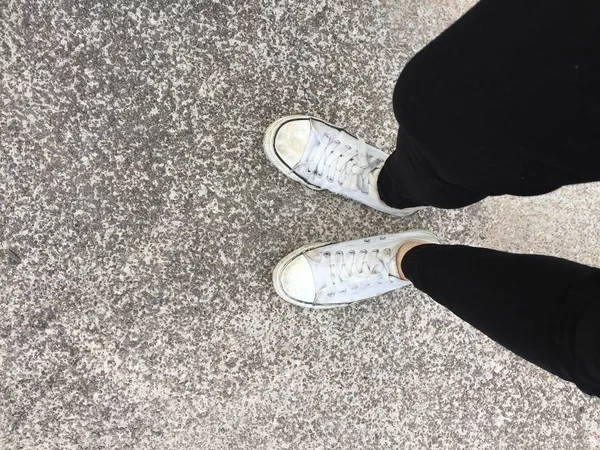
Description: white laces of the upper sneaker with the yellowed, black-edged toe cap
xmin=298 ymin=132 xmax=384 ymax=194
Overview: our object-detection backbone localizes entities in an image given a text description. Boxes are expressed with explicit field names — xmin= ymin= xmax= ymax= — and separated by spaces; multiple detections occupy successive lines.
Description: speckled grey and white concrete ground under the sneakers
xmin=0 ymin=0 xmax=600 ymax=450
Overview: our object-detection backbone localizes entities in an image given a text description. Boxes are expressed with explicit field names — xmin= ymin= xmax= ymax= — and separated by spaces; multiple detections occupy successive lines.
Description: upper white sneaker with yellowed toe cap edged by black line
xmin=263 ymin=116 xmax=422 ymax=217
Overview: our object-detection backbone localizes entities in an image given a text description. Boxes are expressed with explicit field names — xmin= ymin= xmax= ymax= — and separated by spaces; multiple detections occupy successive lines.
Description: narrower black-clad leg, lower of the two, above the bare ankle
xmin=400 ymin=244 xmax=600 ymax=395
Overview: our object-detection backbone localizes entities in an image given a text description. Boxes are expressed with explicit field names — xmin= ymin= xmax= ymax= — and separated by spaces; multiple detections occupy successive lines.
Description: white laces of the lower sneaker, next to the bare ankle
xmin=320 ymin=248 xmax=395 ymax=297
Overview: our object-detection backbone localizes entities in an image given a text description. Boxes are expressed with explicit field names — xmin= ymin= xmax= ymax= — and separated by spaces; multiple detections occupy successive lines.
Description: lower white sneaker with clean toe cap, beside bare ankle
xmin=273 ymin=230 xmax=440 ymax=309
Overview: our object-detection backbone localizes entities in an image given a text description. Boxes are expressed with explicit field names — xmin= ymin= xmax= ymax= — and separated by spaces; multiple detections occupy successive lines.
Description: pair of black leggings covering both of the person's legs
xmin=379 ymin=0 xmax=600 ymax=395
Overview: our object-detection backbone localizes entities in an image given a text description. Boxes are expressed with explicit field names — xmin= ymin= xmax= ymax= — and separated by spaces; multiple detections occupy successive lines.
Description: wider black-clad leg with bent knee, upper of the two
xmin=378 ymin=0 xmax=600 ymax=208
